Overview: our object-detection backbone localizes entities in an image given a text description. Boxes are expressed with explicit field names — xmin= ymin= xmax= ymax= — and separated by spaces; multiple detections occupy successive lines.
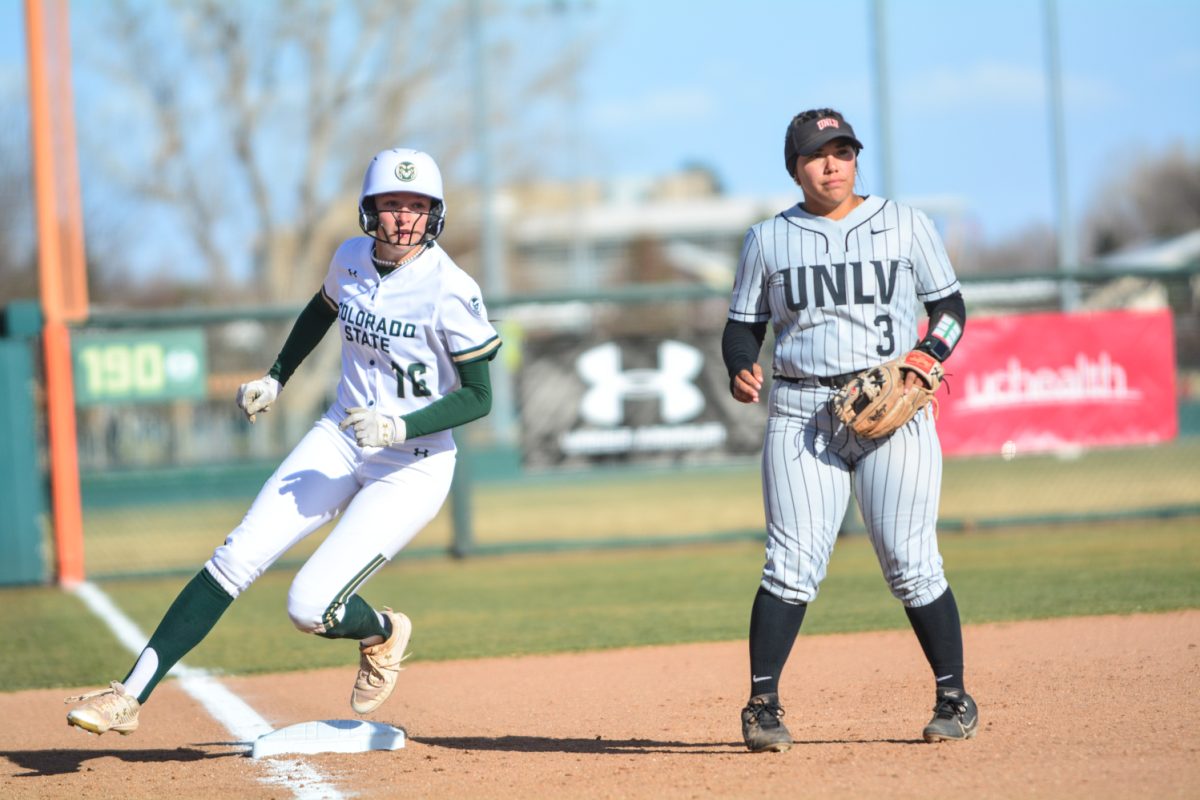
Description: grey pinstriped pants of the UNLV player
xmin=762 ymin=380 xmax=947 ymax=607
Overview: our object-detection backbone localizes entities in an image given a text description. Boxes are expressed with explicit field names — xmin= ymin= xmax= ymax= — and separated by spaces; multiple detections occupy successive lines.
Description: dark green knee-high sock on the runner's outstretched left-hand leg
xmin=122 ymin=570 xmax=233 ymax=703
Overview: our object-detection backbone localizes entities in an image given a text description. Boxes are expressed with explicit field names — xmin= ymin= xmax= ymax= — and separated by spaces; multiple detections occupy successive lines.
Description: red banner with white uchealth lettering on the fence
xmin=937 ymin=309 xmax=1178 ymax=456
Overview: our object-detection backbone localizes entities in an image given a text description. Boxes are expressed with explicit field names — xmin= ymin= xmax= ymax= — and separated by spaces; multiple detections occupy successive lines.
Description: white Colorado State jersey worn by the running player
xmin=322 ymin=236 xmax=500 ymax=452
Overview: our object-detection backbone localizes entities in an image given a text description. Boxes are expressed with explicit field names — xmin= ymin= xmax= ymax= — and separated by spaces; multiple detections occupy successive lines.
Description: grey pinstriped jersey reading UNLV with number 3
xmin=730 ymin=197 xmax=959 ymax=378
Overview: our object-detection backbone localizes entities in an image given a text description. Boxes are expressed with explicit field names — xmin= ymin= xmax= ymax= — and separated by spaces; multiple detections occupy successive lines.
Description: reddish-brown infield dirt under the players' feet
xmin=0 ymin=610 xmax=1200 ymax=800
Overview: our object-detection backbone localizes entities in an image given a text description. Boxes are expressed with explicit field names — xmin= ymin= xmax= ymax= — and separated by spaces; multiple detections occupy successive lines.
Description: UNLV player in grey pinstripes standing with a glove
xmin=722 ymin=109 xmax=978 ymax=752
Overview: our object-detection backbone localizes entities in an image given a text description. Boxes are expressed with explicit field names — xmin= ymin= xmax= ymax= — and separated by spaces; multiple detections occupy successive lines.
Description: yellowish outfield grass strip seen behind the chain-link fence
xmin=77 ymin=438 xmax=1200 ymax=576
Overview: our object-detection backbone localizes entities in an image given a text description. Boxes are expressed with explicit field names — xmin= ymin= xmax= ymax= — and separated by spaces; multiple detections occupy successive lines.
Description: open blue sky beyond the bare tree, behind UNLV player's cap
xmin=0 ymin=0 xmax=1200 ymax=256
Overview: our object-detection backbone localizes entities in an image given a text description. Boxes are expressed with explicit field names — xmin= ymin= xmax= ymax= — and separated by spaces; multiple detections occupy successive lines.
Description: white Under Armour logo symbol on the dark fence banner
xmin=577 ymin=341 xmax=704 ymax=426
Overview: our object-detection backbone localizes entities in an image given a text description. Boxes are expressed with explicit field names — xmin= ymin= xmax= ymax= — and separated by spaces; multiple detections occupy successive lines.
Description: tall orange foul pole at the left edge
xmin=25 ymin=0 xmax=88 ymax=585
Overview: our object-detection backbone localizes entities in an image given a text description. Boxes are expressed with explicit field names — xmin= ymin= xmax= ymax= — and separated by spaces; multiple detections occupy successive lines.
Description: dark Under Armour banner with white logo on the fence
xmin=520 ymin=333 xmax=766 ymax=467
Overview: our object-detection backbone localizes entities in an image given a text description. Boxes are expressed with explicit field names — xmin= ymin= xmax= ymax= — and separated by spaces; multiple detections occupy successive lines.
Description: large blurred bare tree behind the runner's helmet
xmin=77 ymin=0 xmax=574 ymax=302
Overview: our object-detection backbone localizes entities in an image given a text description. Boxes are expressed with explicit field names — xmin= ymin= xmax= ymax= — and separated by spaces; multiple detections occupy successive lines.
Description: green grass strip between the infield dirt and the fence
xmin=0 ymin=518 xmax=1200 ymax=691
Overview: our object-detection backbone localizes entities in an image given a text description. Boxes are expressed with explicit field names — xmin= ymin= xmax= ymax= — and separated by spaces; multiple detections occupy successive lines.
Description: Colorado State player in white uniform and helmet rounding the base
xmin=67 ymin=149 xmax=500 ymax=734
